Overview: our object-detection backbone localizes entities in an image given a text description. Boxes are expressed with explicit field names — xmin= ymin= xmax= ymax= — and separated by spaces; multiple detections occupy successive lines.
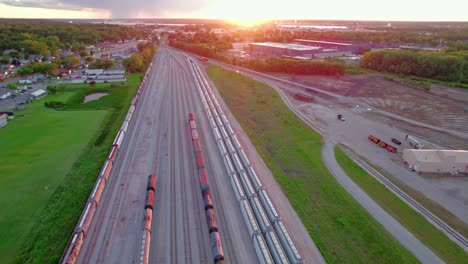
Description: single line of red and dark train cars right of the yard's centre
xmin=189 ymin=113 xmax=224 ymax=264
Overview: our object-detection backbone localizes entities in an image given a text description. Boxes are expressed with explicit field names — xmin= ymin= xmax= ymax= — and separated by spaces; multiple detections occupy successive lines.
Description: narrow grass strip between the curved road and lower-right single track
xmin=335 ymin=147 xmax=468 ymax=263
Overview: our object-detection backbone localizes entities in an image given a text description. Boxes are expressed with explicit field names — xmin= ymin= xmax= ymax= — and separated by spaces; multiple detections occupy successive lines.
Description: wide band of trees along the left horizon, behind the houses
xmin=0 ymin=20 xmax=151 ymax=51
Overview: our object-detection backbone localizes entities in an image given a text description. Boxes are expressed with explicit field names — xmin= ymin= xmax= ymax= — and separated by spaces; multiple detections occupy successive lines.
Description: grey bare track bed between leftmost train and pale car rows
xmin=78 ymin=46 xmax=257 ymax=263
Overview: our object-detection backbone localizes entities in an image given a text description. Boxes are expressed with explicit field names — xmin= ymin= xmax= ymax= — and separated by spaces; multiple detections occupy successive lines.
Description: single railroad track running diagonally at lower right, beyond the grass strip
xmin=343 ymin=148 xmax=468 ymax=251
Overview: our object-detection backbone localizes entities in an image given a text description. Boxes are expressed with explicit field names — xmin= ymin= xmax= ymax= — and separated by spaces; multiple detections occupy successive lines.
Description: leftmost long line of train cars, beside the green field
xmin=60 ymin=63 xmax=153 ymax=264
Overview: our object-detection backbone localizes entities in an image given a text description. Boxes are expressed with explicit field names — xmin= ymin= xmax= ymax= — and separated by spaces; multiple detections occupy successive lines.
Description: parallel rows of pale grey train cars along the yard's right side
xmin=189 ymin=59 xmax=303 ymax=264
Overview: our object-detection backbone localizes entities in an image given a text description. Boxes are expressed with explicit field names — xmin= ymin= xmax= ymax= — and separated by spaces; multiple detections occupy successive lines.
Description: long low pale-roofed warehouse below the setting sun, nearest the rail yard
xmin=248 ymin=42 xmax=321 ymax=58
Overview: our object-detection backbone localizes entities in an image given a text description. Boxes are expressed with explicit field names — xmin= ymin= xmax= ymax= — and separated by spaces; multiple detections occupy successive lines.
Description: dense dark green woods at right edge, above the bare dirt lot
xmin=361 ymin=50 xmax=468 ymax=84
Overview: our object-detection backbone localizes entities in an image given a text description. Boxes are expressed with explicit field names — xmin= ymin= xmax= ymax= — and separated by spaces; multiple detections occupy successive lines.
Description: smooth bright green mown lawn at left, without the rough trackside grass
xmin=0 ymin=93 xmax=108 ymax=263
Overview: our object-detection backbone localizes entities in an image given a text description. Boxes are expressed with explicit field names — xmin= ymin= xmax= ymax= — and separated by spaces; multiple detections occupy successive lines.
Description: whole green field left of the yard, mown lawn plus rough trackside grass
xmin=0 ymin=75 xmax=141 ymax=263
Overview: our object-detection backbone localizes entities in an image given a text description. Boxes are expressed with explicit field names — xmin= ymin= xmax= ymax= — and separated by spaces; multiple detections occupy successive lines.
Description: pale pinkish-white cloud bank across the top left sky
xmin=0 ymin=0 xmax=209 ymax=18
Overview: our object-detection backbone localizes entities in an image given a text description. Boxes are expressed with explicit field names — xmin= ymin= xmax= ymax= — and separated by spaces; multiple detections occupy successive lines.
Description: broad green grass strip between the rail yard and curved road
xmin=208 ymin=64 xmax=417 ymax=263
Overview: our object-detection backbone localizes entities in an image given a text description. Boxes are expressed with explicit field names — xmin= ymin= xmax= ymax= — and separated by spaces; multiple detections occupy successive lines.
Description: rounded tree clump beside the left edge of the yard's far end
xmin=122 ymin=43 xmax=156 ymax=73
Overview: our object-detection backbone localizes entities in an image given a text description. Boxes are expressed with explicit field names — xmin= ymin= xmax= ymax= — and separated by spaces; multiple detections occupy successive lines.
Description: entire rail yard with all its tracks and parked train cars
xmin=62 ymin=46 xmax=324 ymax=263
